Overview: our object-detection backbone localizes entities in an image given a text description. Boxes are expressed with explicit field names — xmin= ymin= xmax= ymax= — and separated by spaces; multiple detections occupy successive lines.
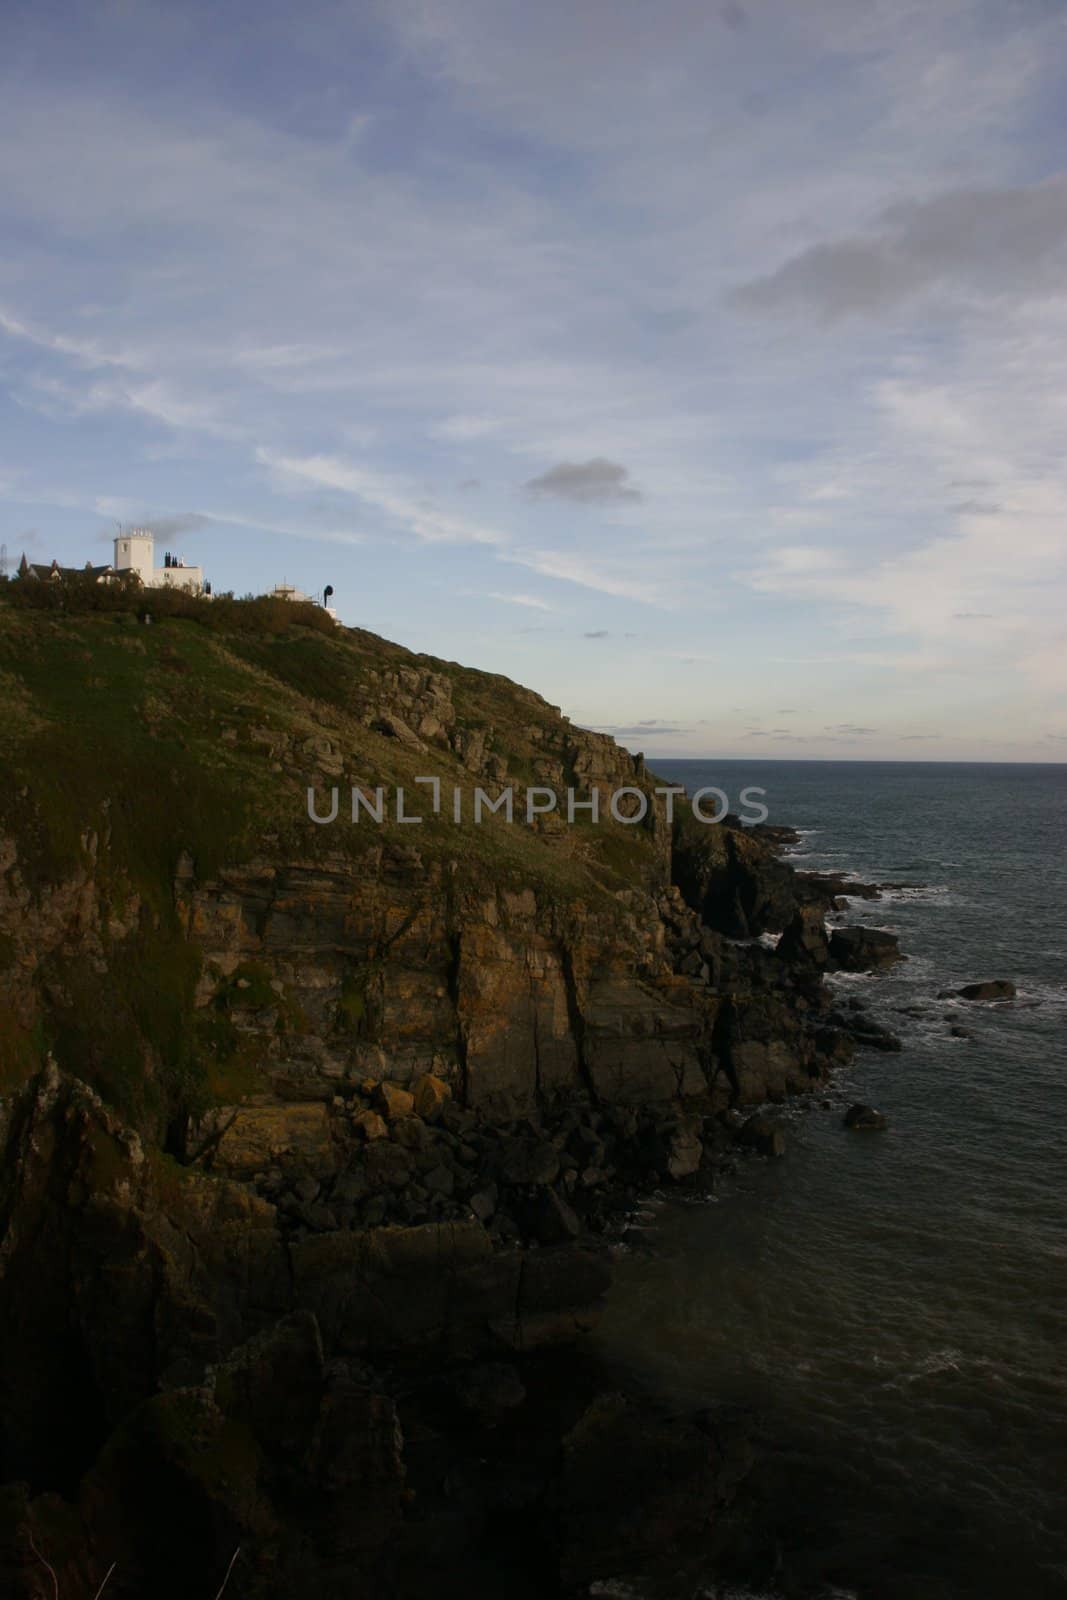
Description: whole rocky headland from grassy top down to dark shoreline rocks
xmin=0 ymin=605 xmax=883 ymax=1600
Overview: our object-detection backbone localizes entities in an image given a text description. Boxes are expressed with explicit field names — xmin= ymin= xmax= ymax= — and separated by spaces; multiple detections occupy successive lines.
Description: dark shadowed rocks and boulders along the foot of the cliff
xmin=0 ymin=834 xmax=897 ymax=1600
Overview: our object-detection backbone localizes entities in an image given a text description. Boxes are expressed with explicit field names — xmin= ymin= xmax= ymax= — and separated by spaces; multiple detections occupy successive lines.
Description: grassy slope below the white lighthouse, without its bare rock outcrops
xmin=0 ymin=603 xmax=668 ymax=1123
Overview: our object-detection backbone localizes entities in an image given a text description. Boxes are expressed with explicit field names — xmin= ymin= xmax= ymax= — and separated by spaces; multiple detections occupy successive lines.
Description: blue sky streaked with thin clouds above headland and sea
xmin=0 ymin=0 xmax=1067 ymax=762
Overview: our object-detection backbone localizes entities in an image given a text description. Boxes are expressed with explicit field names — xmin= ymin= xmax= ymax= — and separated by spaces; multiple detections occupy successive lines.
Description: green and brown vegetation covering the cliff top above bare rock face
xmin=0 ymin=584 xmax=661 ymax=1118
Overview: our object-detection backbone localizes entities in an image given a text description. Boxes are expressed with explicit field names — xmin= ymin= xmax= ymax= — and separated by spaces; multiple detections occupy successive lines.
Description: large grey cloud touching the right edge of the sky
xmin=731 ymin=178 xmax=1067 ymax=318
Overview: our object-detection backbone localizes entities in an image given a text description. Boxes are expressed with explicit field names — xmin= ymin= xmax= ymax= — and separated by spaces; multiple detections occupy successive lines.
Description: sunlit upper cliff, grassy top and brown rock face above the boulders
xmin=0 ymin=608 xmax=851 ymax=1149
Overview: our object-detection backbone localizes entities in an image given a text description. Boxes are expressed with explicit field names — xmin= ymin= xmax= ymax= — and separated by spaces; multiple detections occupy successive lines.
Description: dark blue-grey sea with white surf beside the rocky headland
xmin=598 ymin=762 xmax=1067 ymax=1600
